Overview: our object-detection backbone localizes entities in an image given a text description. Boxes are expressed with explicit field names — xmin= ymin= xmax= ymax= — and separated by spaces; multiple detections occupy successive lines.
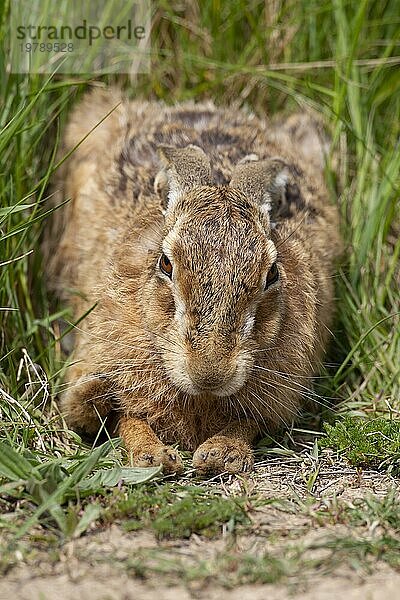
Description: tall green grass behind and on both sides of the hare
xmin=0 ymin=0 xmax=400 ymax=510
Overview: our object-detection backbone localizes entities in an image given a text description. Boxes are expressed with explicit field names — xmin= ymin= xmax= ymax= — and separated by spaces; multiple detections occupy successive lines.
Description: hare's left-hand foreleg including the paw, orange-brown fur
xmin=119 ymin=417 xmax=183 ymax=473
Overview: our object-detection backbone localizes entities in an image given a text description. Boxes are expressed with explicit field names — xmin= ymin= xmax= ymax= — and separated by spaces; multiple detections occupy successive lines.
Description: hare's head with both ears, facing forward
xmin=144 ymin=146 xmax=287 ymax=396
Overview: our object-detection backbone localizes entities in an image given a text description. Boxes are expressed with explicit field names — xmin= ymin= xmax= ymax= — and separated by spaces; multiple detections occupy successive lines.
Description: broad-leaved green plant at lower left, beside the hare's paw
xmin=0 ymin=440 xmax=161 ymax=538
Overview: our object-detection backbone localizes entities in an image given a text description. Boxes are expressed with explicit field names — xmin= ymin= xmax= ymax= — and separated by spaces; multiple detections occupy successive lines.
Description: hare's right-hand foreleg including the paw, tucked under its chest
xmin=193 ymin=421 xmax=259 ymax=473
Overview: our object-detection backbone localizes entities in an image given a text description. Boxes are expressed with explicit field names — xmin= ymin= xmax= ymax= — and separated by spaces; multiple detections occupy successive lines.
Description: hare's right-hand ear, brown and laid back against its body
xmin=229 ymin=154 xmax=292 ymax=213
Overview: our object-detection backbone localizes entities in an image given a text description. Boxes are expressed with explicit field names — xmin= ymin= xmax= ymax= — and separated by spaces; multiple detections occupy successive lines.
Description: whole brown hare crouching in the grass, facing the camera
xmin=46 ymin=89 xmax=341 ymax=473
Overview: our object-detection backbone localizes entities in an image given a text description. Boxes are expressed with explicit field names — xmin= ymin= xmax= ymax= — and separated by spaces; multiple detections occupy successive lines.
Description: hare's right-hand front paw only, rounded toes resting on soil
xmin=193 ymin=435 xmax=254 ymax=473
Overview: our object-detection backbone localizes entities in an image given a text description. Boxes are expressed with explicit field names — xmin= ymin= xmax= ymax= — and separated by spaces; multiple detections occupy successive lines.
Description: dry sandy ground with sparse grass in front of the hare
xmin=0 ymin=450 xmax=400 ymax=600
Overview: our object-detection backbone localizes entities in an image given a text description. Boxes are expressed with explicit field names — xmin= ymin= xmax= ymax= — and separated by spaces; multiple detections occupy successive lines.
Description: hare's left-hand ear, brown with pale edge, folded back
xmin=154 ymin=144 xmax=211 ymax=211
